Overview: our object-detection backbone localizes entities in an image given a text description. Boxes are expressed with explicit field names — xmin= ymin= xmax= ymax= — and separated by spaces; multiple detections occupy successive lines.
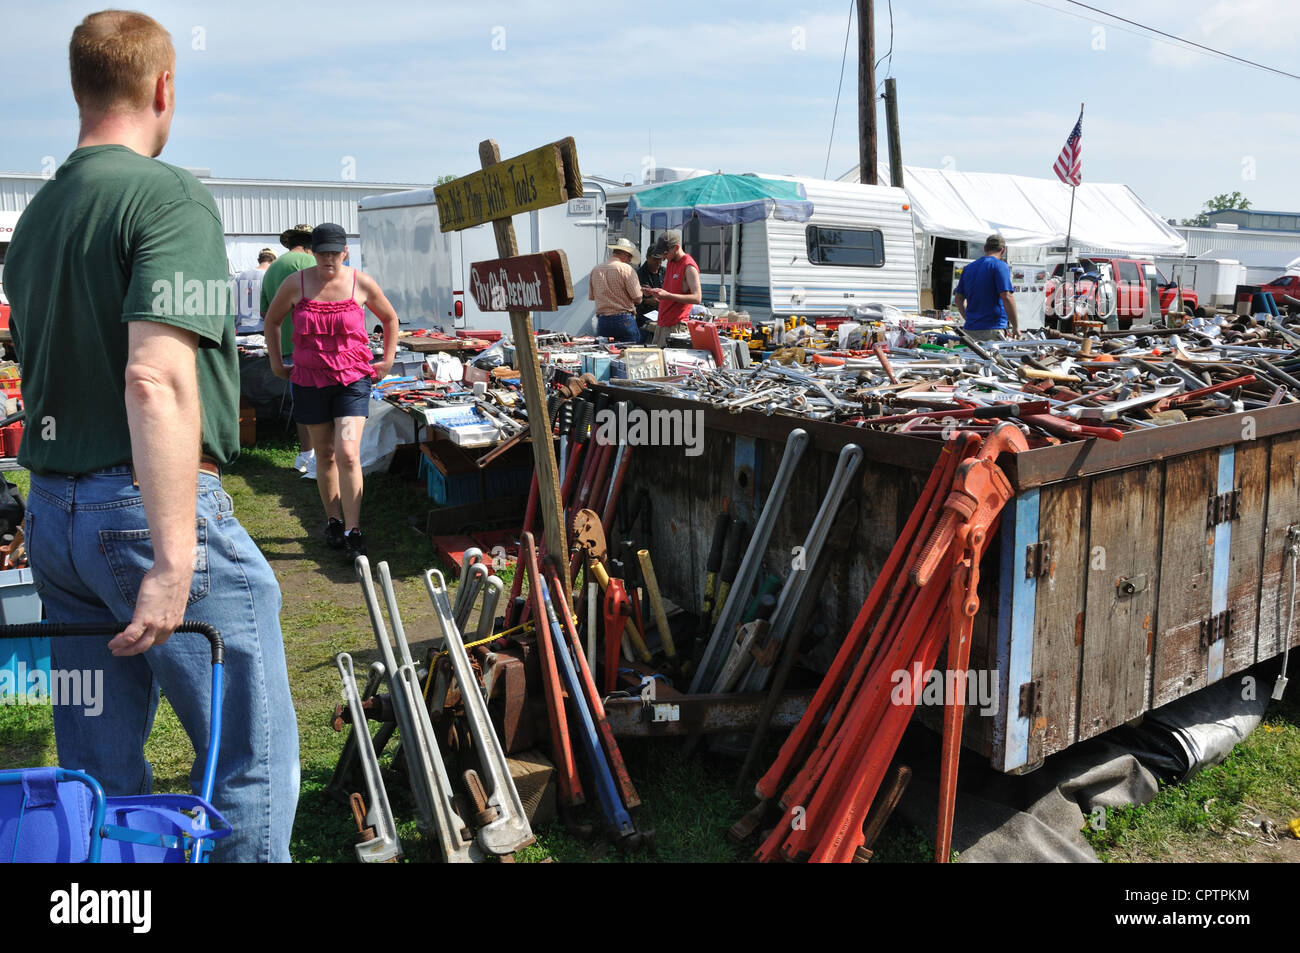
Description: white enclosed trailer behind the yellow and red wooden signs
xmin=358 ymin=179 xmax=608 ymax=333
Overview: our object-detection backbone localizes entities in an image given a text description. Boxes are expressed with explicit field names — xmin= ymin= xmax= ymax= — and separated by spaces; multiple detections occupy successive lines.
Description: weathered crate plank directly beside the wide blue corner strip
xmin=1017 ymin=481 xmax=1088 ymax=763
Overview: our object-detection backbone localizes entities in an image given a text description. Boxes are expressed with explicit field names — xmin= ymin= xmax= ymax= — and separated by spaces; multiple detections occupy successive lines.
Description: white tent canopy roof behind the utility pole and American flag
xmin=845 ymin=165 xmax=1187 ymax=255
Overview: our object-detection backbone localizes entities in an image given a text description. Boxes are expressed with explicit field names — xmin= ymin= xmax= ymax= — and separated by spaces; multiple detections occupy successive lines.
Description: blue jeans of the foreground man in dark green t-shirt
xmin=26 ymin=467 xmax=299 ymax=862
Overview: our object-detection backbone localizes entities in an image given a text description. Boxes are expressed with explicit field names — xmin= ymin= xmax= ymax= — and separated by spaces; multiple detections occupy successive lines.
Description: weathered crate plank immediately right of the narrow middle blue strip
xmin=1223 ymin=441 xmax=1269 ymax=675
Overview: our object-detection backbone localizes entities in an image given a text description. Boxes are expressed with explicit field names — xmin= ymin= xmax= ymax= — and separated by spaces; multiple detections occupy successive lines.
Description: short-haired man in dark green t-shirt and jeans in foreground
xmin=4 ymin=10 xmax=299 ymax=861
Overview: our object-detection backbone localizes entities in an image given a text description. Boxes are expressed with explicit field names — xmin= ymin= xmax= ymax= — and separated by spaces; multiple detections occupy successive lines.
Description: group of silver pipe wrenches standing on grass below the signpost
xmin=332 ymin=556 xmax=534 ymax=863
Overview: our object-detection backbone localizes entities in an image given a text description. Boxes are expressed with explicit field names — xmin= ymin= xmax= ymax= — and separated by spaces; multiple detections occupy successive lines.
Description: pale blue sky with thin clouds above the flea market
xmin=0 ymin=0 xmax=1300 ymax=217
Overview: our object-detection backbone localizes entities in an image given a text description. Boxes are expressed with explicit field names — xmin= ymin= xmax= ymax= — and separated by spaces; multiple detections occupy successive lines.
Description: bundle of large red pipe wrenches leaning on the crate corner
xmin=737 ymin=423 xmax=1027 ymax=863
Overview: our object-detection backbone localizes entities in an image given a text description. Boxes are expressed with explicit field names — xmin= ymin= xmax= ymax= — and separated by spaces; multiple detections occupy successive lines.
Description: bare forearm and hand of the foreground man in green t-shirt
xmin=108 ymin=321 xmax=200 ymax=655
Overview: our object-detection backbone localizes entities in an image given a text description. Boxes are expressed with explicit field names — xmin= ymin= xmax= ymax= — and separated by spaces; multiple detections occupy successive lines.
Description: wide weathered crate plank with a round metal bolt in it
xmin=1079 ymin=463 xmax=1162 ymax=741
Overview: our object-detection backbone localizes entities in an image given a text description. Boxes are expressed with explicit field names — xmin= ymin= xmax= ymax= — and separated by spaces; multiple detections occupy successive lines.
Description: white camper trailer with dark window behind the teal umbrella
xmin=608 ymin=174 xmax=919 ymax=321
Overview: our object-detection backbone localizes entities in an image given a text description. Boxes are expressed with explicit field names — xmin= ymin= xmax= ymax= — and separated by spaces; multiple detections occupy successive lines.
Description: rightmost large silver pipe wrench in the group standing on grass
xmin=424 ymin=569 xmax=534 ymax=855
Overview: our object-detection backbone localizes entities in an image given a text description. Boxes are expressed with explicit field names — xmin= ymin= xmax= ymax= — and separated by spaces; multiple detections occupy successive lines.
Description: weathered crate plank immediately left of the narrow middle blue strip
xmin=1141 ymin=450 xmax=1219 ymax=707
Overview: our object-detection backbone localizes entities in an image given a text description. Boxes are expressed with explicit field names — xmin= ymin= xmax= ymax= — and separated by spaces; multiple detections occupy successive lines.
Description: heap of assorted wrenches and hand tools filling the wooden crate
xmin=618 ymin=315 xmax=1300 ymax=447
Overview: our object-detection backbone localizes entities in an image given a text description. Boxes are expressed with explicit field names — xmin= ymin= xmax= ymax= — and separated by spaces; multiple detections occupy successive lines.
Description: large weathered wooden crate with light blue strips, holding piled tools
xmin=611 ymin=387 xmax=1300 ymax=771
